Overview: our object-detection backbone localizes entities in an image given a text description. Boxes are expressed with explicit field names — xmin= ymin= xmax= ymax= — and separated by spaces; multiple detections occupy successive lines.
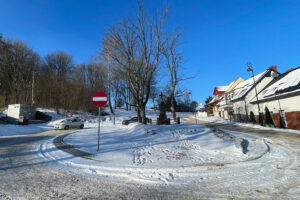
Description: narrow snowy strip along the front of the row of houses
xmin=197 ymin=116 xmax=300 ymax=134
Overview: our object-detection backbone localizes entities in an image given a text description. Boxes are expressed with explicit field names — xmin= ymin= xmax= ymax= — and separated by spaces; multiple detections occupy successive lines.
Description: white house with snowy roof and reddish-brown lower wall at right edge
xmin=250 ymin=67 xmax=300 ymax=129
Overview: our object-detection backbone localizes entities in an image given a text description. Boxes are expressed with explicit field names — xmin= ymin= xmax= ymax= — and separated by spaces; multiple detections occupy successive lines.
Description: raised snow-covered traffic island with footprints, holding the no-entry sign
xmin=64 ymin=122 xmax=253 ymax=168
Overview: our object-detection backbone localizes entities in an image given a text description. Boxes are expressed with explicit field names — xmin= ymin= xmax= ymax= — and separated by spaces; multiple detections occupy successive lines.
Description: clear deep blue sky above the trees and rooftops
xmin=0 ymin=0 xmax=300 ymax=102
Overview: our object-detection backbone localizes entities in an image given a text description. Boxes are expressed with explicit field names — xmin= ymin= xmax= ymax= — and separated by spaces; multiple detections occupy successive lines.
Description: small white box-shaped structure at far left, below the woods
xmin=7 ymin=104 xmax=36 ymax=123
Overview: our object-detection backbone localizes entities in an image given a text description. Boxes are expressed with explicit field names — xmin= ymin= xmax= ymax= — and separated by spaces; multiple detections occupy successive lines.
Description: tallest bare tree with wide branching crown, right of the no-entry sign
xmin=102 ymin=1 xmax=168 ymax=124
